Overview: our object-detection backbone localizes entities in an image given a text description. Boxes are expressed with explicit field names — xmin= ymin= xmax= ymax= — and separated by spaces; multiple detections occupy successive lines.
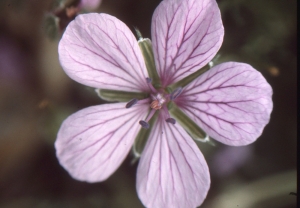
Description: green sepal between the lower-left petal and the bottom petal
xmin=132 ymin=111 xmax=159 ymax=158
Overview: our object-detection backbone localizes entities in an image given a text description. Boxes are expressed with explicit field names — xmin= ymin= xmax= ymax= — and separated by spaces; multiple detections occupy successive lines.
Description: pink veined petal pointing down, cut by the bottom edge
xmin=137 ymin=115 xmax=210 ymax=208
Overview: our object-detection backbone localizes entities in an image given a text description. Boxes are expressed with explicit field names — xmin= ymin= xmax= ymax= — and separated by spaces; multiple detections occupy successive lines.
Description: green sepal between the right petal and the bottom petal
xmin=168 ymin=102 xmax=208 ymax=142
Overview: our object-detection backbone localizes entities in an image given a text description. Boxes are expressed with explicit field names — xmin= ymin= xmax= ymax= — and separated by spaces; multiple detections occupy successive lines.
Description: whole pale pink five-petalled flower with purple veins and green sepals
xmin=55 ymin=0 xmax=273 ymax=208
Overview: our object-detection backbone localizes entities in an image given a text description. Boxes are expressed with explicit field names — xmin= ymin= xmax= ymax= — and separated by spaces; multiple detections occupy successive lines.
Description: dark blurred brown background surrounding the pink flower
xmin=0 ymin=0 xmax=297 ymax=208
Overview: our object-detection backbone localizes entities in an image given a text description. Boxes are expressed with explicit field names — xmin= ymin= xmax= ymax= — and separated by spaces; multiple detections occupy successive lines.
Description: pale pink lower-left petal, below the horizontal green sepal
xmin=55 ymin=103 xmax=149 ymax=182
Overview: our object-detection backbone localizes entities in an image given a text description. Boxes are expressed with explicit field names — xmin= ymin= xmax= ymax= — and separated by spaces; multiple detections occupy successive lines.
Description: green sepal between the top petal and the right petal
xmin=166 ymin=64 xmax=210 ymax=93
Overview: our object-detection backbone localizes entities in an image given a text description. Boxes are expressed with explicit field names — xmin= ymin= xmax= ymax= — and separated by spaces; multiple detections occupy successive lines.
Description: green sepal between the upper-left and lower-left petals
xmin=95 ymin=89 xmax=149 ymax=102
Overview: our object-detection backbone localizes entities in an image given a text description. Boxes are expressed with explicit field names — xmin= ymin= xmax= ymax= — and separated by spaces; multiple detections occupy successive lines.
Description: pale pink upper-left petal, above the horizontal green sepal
xmin=58 ymin=13 xmax=148 ymax=92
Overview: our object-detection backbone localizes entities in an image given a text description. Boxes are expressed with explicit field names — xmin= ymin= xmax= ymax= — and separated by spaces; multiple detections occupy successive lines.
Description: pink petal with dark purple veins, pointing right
xmin=177 ymin=62 xmax=273 ymax=146
